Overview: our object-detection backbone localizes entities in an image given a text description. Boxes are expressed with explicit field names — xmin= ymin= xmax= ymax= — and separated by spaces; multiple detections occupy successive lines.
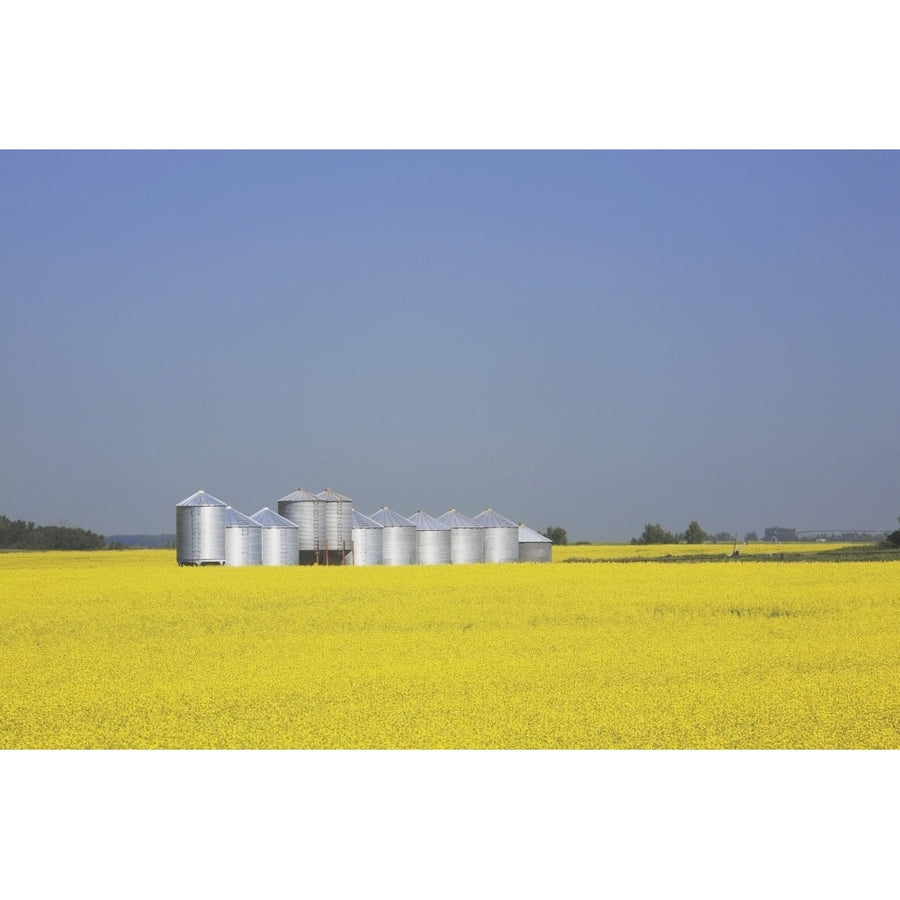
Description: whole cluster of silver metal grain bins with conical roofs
xmin=175 ymin=488 xmax=552 ymax=566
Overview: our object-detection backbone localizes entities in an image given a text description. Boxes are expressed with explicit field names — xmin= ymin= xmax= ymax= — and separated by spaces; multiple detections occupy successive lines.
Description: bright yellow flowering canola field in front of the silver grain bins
xmin=0 ymin=551 xmax=900 ymax=749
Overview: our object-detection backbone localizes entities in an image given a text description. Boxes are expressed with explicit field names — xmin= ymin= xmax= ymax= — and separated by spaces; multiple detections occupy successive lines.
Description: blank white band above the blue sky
xmin=0 ymin=0 xmax=900 ymax=149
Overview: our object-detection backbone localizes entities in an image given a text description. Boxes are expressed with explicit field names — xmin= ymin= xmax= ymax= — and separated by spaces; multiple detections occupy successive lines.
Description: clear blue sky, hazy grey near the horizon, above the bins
xmin=0 ymin=151 xmax=900 ymax=540
